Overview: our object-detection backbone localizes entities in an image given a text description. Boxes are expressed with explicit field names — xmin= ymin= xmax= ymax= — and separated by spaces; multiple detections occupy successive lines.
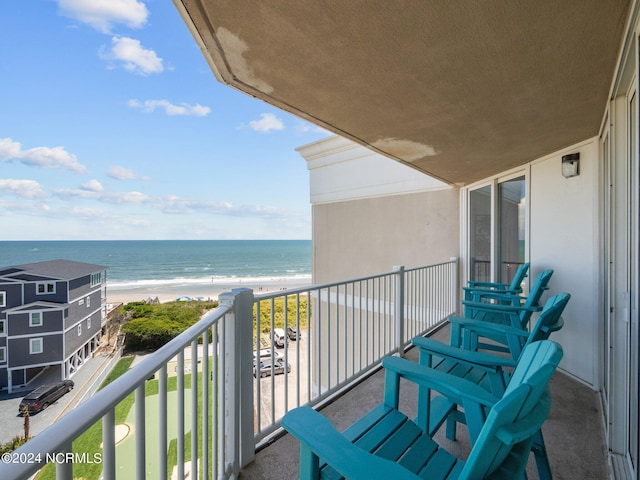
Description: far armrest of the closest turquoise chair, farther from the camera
xmin=382 ymin=357 xmax=499 ymax=408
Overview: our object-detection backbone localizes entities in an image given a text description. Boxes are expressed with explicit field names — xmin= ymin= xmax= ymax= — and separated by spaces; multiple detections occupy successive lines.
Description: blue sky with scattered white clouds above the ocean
xmin=0 ymin=0 xmax=329 ymax=240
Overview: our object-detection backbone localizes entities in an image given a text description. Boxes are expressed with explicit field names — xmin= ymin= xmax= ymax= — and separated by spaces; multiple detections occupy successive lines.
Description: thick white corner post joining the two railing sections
xmin=218 ymin=288 xmax=255 ymax=478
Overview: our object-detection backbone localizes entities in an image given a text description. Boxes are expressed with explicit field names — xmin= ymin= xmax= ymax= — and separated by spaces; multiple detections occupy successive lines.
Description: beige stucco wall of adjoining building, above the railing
xmin=313 ymin=188 xmax=460 ymax=283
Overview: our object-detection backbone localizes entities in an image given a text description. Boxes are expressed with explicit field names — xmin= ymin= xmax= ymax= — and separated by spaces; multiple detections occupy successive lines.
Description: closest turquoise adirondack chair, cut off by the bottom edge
xmin=282 ymin=340 xmax=562 ymax=480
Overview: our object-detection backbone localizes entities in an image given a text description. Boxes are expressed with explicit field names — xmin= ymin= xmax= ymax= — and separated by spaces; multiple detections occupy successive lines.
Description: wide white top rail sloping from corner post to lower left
xmin=0 ymin=305 xmax=231 ymax=478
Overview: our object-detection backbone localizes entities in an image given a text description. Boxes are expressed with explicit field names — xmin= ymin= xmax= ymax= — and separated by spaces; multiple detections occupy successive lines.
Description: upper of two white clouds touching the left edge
xmin=0 ymin=138 xmax=87 ymax=173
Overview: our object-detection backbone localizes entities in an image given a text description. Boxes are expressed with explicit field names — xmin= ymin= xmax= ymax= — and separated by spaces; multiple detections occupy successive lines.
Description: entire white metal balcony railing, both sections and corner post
xmin=0 ymin=259 xmax=458 ymax=480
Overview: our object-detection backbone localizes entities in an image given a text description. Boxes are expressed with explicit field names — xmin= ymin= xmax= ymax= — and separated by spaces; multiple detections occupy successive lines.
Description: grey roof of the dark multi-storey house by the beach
xmin=0 ymin=259 xmax=106 ymax=281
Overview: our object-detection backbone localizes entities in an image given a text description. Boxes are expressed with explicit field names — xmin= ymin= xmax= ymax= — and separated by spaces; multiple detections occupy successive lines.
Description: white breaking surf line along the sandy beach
xmin=107 ymin=274 xmax=311 ymax=290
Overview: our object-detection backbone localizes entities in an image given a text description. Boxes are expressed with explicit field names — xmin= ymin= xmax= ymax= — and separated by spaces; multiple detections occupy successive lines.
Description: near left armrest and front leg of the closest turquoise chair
xmin=282 ymin=407 xmax=418 ymax=480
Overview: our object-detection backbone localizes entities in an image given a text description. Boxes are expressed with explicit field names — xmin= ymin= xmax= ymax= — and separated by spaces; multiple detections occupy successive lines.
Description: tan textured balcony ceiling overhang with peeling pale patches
xmin=174 ymin=0 xmax=630 ymax=185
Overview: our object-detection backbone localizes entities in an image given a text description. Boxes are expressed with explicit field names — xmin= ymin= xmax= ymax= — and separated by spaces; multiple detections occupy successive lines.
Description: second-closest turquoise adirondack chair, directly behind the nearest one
xmin=412 ymin=293 xmax=571 ymax=479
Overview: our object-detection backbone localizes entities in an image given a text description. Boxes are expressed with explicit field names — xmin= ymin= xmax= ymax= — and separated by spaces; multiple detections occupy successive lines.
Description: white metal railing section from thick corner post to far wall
xmin=254 ymin=259 xmax=458 ymax=447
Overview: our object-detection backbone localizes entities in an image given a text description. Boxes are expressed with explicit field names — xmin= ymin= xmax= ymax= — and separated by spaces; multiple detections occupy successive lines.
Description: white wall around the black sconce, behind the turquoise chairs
xmin=530 ymin=139 xmax=600 ymax=386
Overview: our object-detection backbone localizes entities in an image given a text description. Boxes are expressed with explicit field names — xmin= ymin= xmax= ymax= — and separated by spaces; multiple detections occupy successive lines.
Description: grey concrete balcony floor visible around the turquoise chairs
xmin=241 ymin=329 xmax=610 ymax=480
